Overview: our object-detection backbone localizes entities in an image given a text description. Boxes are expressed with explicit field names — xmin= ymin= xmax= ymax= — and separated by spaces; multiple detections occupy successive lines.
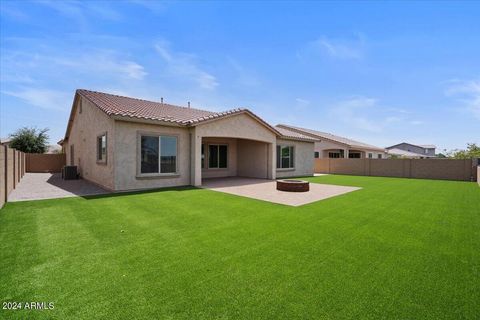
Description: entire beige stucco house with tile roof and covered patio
xmin=62 ymin=90 xmax=314 ymax=190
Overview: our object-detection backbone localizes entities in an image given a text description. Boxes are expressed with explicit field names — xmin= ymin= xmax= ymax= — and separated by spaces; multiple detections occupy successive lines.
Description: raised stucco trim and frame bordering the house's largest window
xmin=135 ymin=130 xmax=181 ymax=179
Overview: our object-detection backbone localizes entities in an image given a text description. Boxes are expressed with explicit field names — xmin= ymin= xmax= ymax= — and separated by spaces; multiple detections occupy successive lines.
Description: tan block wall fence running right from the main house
xmin=314 ymin=159 xmax=479 ymax=181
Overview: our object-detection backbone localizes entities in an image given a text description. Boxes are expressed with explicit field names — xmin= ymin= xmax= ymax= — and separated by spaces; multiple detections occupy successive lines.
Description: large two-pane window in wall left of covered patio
xmin=140 ymin=135 xmax=177 ymax=174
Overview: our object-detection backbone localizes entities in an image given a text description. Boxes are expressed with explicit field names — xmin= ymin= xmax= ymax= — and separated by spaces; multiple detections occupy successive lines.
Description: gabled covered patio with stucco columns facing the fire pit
xmin=190 ymin=111 xmax=278 ymax=186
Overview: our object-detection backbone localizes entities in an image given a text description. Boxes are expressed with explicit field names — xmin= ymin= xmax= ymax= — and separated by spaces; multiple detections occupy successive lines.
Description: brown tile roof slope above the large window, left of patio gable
xmin=77 ymin=89 xmax=245 ymax=125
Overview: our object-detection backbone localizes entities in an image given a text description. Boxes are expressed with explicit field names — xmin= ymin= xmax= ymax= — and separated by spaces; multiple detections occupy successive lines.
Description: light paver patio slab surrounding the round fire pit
xmin=202 ymin=177 xmax=361 ymax=207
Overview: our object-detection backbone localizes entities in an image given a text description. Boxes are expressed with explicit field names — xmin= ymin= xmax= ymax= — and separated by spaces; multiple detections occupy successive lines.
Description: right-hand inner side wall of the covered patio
xmin=238 ymin=139 xmax=270 ymax=179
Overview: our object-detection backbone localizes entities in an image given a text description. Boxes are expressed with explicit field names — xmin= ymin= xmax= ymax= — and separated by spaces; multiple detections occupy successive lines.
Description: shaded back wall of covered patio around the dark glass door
xmin=202 ymin=137 xmax=237 ymax=178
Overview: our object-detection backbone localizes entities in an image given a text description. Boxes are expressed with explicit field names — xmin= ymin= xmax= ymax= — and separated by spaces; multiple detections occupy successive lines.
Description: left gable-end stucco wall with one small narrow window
xmin=65 ymin=97 xmax=115 ymax=189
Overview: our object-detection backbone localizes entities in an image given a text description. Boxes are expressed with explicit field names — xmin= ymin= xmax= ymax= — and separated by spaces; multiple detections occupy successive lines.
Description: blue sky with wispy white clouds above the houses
xmin=0 ymin=1 xmax=480 ymax=151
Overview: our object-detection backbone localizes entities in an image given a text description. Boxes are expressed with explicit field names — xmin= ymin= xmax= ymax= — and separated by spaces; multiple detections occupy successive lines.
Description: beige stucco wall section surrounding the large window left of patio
xmin=115 ymin=120 xmax=190 ymax=190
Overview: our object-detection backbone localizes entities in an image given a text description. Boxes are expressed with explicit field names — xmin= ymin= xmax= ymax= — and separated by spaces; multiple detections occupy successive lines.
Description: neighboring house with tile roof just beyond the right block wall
xmin=276 ymin=124 xmax=386 ymax=159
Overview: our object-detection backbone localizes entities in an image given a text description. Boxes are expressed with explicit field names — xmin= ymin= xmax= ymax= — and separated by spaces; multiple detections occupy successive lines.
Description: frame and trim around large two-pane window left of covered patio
xmin=137 ymin=131 xmax=180 ymax=178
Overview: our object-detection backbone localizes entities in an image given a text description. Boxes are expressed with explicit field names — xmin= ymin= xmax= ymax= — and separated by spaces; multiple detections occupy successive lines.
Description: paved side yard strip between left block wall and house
xmin=8 ymin=173 xmax=108 ymax=202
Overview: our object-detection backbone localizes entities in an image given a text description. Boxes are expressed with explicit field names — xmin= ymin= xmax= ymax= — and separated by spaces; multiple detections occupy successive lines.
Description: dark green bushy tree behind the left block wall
xmin=9 ymin=127 xmax=48 ymax=153
